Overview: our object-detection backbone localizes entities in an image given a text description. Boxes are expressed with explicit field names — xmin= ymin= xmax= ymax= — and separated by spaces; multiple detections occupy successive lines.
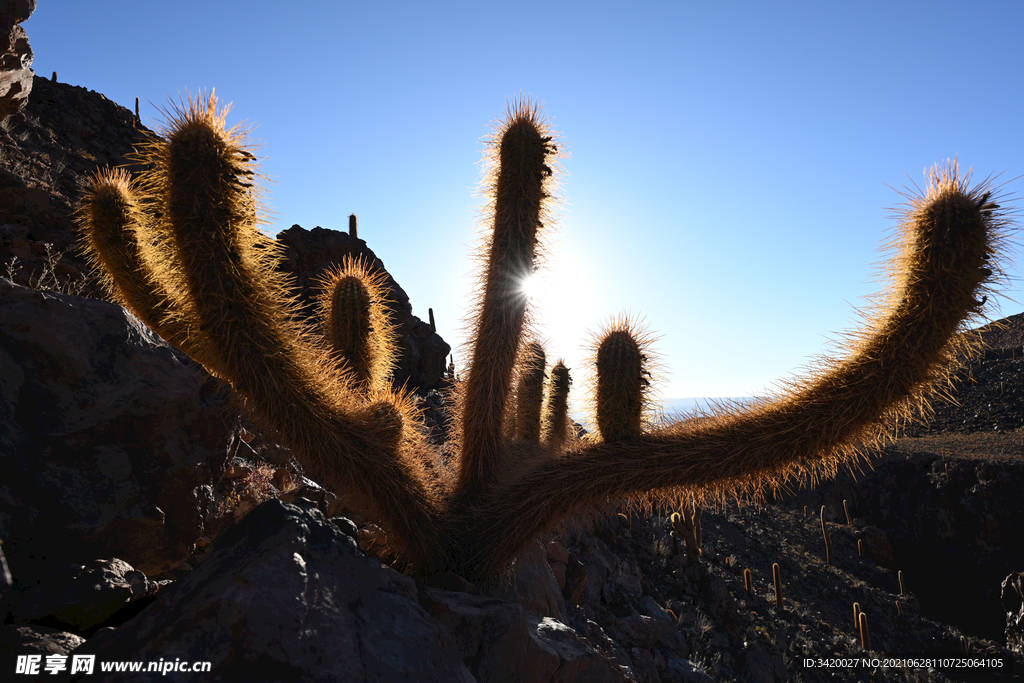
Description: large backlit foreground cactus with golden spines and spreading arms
xmin=82 ymin=90 xmax=1007 ymax=578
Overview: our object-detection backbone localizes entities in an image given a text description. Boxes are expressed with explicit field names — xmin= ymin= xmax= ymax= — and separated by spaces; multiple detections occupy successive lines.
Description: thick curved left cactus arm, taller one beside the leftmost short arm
xmin=135 ymin=94 xmax=437 ymax=569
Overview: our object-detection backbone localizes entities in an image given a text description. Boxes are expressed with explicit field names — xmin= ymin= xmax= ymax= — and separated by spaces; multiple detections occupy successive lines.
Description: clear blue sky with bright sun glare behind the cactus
xmin=25 ymin=0 xmax=1024 ymax=411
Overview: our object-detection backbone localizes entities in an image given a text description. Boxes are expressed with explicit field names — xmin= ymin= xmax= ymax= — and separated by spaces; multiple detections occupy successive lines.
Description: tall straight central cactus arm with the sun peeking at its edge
xmin=455 ymin=102 xmax=557 ymax=501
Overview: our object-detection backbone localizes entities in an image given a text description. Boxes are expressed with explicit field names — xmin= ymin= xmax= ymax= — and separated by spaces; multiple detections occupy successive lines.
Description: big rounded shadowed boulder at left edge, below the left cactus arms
xmin=0 ymin=278 xmax=233 ymax=582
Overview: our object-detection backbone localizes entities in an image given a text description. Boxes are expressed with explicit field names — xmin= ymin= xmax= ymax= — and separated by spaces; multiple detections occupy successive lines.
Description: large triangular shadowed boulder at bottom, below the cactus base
xmin=75 ymin=500 xmax=473 ymax=683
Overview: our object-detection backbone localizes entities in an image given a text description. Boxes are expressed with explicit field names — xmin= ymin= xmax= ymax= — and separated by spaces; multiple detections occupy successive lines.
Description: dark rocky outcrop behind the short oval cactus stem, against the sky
xmin=278 ymin=225 xmax=452 ymax=392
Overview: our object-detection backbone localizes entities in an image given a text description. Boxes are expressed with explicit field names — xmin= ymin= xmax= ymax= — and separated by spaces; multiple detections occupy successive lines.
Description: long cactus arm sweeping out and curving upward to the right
xmin=466 ymin=164 xmax=1009 ymax=575
